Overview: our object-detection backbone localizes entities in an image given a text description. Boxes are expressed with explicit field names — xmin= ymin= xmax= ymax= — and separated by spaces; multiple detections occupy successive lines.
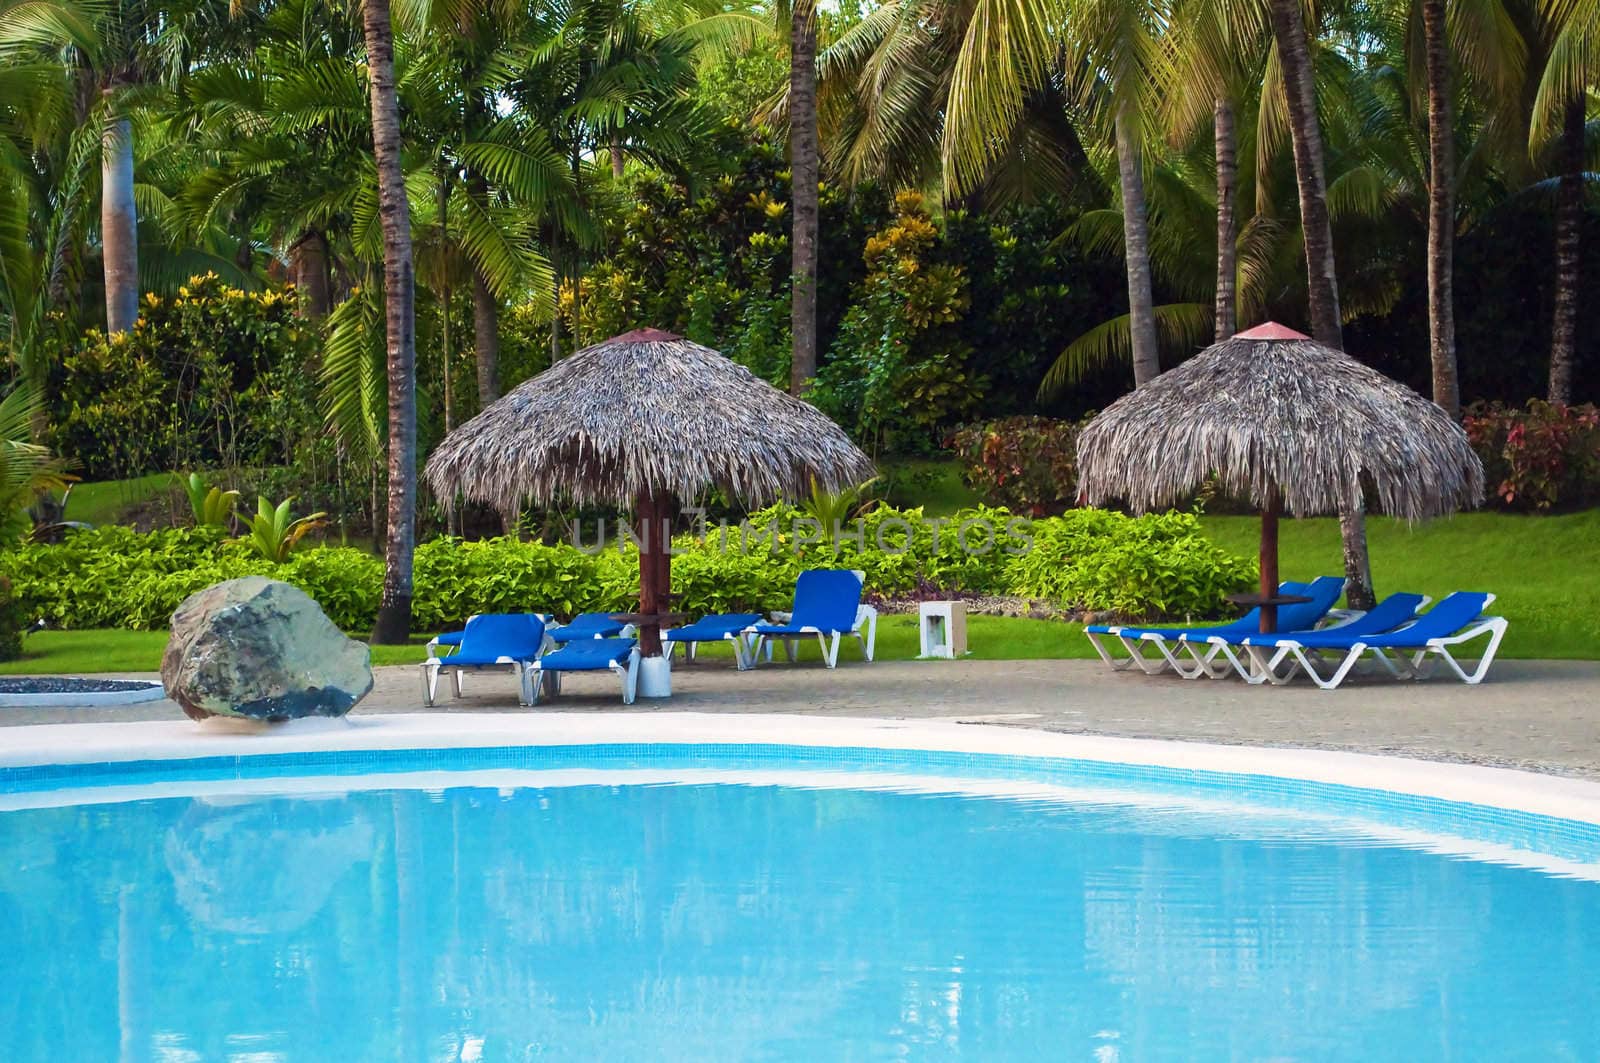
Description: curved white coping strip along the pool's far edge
xmin=9 ymin=711 xmax=1600 ymax=826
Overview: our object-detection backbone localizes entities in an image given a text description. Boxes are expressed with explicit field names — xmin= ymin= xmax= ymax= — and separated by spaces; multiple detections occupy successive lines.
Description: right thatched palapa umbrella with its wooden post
xmin=1078 ymin=322 xmax=1483 ymax=631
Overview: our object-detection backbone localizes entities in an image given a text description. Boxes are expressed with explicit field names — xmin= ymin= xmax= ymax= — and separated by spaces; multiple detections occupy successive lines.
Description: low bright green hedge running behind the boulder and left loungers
xmin=0 ymin=506 xmax=1254 ymax=631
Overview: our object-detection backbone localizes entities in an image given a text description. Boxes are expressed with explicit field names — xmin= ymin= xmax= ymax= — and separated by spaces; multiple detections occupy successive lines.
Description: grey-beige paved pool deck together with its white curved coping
xmin=0 ymin=661 xmax=1600 ymax=824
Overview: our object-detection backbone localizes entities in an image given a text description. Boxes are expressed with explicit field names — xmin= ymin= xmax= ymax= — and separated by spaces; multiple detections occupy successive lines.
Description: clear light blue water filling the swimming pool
xmin=0 ymin=775 xmax=1600 ymax=1063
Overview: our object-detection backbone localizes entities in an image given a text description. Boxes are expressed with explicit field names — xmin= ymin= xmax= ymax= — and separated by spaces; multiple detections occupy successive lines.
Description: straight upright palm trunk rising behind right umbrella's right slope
xmin=1422 ymin=0 xmax=1461 ymax=418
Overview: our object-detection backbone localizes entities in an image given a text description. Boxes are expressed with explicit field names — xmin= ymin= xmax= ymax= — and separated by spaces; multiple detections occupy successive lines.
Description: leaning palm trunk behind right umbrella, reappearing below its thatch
xmin=1272 ymin=0 xmax=1374 ymax=608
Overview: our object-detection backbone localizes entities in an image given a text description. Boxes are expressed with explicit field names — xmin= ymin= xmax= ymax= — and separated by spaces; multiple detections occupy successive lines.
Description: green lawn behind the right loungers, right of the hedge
xmin=1203 ymin=509 xmax=1600 ymax=660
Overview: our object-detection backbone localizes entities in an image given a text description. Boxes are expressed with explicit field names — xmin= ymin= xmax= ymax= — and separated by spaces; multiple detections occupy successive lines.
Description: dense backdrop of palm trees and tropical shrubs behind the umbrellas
xmin=9 ymin=0 xmax=1600 ymax=637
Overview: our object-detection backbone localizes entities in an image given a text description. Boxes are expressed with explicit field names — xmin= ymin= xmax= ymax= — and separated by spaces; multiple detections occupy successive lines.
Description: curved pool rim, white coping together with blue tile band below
xmin=9 ymin=712 xmax=1600 ymax=861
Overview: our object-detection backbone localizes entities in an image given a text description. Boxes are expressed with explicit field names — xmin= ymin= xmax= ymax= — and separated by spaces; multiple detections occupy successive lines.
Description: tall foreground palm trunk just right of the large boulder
xmin=362 ymin=0 xmax=416 ymax=645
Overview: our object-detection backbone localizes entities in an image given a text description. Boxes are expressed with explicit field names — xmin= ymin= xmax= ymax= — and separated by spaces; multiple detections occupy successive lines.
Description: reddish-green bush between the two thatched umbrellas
xmin=950 ymin=416 xmax=1083 ymax=517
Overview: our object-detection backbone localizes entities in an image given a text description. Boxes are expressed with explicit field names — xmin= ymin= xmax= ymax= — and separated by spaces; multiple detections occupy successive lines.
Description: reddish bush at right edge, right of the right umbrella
xmin=1464 ymin=399 xmax=1600 ymax=511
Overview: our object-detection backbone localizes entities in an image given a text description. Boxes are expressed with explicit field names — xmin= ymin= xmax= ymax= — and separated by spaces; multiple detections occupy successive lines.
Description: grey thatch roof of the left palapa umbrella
xmin=424 ymin=328 xmax=874 ymax=507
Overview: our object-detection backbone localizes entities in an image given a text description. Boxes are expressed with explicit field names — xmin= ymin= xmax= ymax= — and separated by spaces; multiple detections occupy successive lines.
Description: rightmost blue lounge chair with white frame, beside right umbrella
xmin=1228 ymin=591 xmax=1506 ymax=690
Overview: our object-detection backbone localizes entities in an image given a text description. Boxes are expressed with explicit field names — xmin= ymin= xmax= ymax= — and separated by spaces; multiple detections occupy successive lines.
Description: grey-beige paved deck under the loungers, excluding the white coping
xmin=0 ymin=648 xmax=1600 ymax=780
